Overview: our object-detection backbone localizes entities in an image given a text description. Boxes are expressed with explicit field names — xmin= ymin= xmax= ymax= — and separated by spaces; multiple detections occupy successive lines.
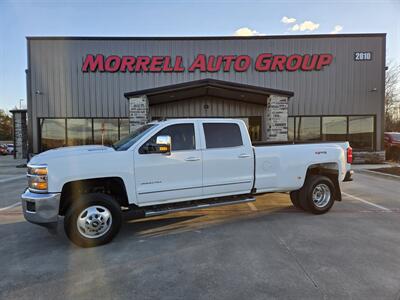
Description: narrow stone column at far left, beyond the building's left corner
xmin=10 ymin=109 xmax=28 ymax=159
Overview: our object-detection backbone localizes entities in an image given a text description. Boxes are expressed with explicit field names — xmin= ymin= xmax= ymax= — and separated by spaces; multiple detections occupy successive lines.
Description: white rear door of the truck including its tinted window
xmin=201 ymin=120 xmax=254 ymax=197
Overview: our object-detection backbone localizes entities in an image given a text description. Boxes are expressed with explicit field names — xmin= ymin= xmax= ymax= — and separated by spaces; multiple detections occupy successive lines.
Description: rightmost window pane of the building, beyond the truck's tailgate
xmin=349 ymin=116 xmax=375 ymax=150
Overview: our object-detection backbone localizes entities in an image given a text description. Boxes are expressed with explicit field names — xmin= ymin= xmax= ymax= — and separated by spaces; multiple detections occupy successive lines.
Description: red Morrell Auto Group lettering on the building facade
xmin=82 ymin=53 xmax=333 ymax=73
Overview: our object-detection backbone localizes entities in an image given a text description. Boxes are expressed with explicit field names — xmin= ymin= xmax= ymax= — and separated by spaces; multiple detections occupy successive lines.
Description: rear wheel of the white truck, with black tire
xmin=299 ymin=175 xmax=335 ymax=215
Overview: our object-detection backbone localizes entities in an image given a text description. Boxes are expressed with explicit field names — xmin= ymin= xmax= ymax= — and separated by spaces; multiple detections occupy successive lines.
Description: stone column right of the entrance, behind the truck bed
xmin=265 ymin=95 xmax=288 ymax=141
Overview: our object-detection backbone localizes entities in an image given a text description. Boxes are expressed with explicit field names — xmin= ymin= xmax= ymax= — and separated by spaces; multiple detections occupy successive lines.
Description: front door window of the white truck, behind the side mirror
xmin=139 ymin=123 xmax=196 ymax=154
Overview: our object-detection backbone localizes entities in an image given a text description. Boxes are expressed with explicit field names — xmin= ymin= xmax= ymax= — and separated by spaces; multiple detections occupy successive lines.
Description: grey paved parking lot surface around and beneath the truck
xmin=0 ymin=157 xmax=400 ymax=299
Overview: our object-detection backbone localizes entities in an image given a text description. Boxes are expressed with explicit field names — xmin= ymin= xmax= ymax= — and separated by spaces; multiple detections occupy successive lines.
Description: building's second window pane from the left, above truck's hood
xmin=67 ymin=119 xmax=93 ymax=146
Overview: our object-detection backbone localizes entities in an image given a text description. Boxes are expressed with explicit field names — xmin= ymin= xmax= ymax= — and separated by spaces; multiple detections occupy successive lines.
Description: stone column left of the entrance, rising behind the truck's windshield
xmin=129 ymin=95 xmax=150 ymax=132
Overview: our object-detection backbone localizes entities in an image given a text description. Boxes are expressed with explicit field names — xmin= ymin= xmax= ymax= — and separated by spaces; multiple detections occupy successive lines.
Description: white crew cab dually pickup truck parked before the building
xmin=22 ymin=119 xmax=352 ymax=247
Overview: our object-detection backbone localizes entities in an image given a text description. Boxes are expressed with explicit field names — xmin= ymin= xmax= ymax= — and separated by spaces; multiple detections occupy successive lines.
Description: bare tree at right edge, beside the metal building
xmin=385 ymin=62 xmax=400 ymax=131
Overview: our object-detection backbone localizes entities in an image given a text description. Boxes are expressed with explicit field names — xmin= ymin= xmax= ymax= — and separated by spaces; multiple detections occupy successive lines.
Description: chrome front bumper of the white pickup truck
xmin=21 ymin=189 xmax=61 ymax=228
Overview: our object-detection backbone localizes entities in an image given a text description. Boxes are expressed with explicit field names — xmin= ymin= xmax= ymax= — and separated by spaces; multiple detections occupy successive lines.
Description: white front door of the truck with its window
xmin=134 ymin=122 xmax=202 ymax=204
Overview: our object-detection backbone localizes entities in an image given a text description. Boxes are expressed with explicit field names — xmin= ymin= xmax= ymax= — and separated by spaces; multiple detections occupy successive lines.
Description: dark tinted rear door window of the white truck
xmin=203 ymin=123 xmax=243 ymax=149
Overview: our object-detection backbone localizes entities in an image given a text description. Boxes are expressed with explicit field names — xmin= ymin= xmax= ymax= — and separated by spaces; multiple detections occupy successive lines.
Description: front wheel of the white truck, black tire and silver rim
xmin=64 ymin=193 xmax=122 ymax=248
